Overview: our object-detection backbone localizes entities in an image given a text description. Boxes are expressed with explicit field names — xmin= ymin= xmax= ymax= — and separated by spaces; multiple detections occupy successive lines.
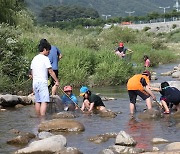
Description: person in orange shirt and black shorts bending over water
xmin=127 ymin=71 xmax=156 ymax=114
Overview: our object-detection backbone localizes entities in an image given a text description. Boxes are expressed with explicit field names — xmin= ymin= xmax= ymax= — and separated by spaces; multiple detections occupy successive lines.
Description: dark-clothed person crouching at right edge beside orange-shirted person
xmin=152 ymin=81 xmax=180 ymax=114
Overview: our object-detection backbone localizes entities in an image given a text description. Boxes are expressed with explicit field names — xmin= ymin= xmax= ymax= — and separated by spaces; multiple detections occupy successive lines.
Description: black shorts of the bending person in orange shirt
xmin=128 ymin=90 xmax=150 ymax=104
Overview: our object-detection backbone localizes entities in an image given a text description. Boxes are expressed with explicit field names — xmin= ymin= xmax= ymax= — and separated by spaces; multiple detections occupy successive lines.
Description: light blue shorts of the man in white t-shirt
xmin=33 ymin=81 xmax=50 ymax=103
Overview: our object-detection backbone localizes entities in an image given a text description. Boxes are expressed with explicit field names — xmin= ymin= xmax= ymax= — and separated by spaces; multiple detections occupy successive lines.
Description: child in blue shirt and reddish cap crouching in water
xmin=61 ymin=85 xmax=78 ymax=111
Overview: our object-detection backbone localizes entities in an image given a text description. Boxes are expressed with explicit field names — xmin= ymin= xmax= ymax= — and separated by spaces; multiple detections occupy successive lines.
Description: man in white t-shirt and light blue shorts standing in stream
xmin=31 ymin=41 xmax=59 ymax=116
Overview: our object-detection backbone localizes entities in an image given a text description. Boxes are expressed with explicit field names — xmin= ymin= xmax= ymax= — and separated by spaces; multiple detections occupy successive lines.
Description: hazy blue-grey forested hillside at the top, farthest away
xmin=25 ymin=0 xmax=175 ymax=17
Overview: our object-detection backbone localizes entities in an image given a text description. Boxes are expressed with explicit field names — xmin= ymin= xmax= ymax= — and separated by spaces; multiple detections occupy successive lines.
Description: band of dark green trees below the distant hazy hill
xmin=41 ymin=11 xmax=180 ymax=29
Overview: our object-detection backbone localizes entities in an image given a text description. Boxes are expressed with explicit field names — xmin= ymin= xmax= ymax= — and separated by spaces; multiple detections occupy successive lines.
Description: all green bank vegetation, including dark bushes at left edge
xmin=0 ymin=0 xmax=178 ymax=93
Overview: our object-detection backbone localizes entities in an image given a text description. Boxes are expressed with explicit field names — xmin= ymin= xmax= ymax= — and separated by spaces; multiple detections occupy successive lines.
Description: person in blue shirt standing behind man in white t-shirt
xmin=40 ymin=39 xmax=62 ymax=95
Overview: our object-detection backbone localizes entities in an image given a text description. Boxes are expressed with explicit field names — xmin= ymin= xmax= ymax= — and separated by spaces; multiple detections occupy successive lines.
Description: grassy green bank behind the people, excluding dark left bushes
xmin=0 ymin=24 xmax=178 ymax=94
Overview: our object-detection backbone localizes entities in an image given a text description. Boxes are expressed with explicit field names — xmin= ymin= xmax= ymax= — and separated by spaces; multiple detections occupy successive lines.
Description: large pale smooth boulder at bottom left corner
xmin=15 ymin=135 xmax=67 ymax=154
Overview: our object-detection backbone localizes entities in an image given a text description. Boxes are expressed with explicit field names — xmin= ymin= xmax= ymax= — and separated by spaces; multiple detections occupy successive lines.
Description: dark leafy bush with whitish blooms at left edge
xmin=0 ymin=24 xmax=29 ymax=93
